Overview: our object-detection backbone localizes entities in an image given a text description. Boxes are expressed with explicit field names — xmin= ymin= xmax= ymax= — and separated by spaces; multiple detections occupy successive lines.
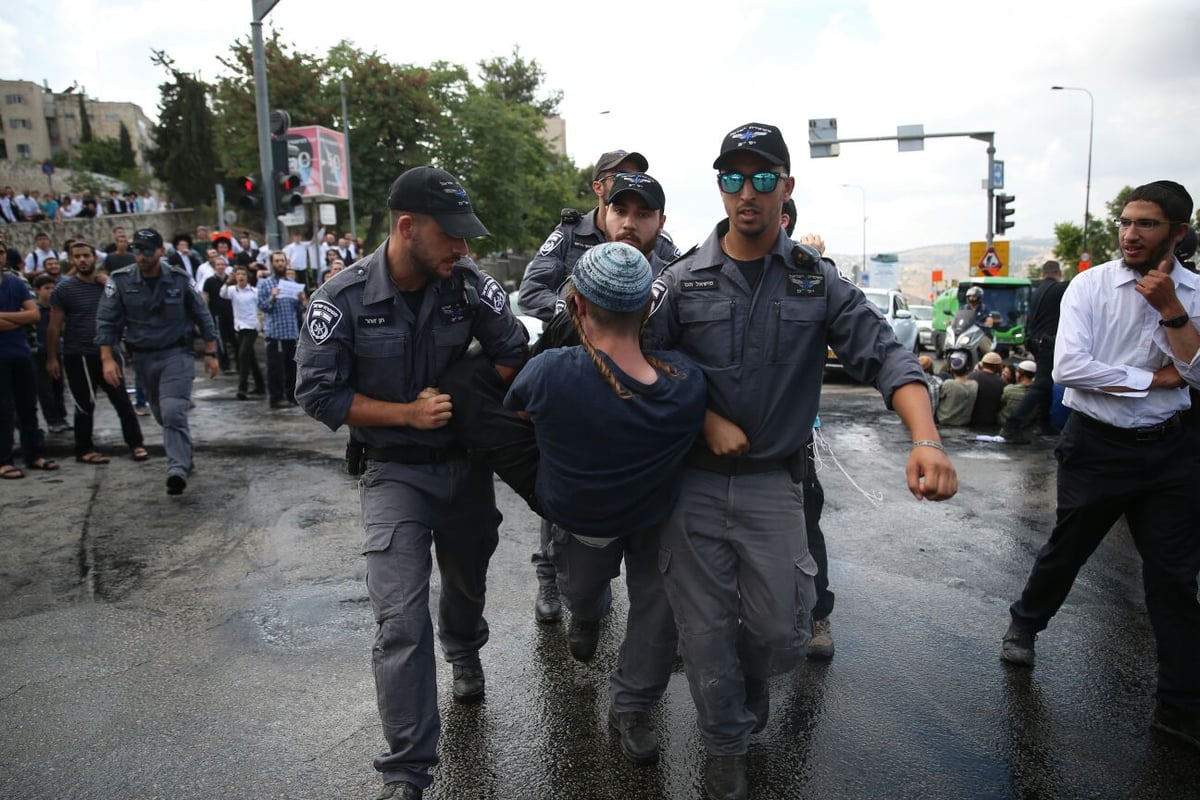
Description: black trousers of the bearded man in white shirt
xmin=1010 ymin=411 xmax=1200 ymax=715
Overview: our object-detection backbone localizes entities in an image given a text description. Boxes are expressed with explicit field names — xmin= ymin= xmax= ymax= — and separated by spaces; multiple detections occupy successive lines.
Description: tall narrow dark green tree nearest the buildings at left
xmin=146 ymin=50 xmax=217 ymax=205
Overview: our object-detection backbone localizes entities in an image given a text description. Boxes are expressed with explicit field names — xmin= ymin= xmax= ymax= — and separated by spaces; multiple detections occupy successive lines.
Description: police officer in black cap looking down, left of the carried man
xmin=296 ymin=167 xmax=528 ymax=800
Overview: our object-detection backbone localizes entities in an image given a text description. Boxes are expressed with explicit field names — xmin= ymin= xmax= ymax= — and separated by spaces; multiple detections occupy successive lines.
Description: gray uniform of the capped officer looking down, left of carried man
xmin=296 ymin=241 xmax=528 ymax=788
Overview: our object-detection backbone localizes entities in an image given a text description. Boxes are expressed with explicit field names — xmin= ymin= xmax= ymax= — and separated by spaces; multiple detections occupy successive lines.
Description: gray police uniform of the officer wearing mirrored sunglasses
xmin=646 ymin=219 xmax=924 ymax=756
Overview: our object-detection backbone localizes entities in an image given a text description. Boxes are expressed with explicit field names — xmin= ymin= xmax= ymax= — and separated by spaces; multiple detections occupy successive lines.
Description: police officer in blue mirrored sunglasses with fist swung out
xmin=646 ymin=122 xmax=958 ymax=799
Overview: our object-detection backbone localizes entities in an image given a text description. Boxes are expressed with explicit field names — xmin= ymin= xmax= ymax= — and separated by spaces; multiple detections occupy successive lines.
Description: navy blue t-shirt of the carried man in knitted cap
xmin=504 ymin=347 xmax=708 ymax=536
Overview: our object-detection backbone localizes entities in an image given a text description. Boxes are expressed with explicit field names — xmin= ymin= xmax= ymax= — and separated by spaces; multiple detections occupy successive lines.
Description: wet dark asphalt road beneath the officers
xmin=0 ymin=364 xmax=1200 ymax=800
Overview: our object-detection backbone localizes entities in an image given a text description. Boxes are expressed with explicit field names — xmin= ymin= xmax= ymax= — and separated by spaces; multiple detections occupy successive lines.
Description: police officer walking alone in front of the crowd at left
xmin=96 ymin=228 xmax=220 ymax=494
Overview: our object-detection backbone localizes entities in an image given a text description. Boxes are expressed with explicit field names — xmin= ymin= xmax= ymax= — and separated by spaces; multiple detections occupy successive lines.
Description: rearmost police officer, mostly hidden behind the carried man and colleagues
xmin=517 ymin=150 xmax=679 ymax=622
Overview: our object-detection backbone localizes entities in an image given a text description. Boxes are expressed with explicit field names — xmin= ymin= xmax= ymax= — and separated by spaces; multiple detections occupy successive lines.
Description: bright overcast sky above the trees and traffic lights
xmin=0 ymin=0 xmax=1200 ymax=262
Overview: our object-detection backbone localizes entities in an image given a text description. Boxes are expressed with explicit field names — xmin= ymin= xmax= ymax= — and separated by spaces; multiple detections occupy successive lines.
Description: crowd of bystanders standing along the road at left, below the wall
xmin=0 ymin=215 xmax=362 ymax=493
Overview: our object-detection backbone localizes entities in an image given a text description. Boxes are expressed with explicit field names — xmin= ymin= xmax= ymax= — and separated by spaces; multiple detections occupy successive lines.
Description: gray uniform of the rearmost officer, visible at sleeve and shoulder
xmin=517 ymin=209 xmax=679 ymax=323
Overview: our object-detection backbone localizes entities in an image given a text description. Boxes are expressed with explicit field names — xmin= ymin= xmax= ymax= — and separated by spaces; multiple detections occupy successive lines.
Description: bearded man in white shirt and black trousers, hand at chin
xmin=1001 ymin=181 xmax=1200 ymax=748
